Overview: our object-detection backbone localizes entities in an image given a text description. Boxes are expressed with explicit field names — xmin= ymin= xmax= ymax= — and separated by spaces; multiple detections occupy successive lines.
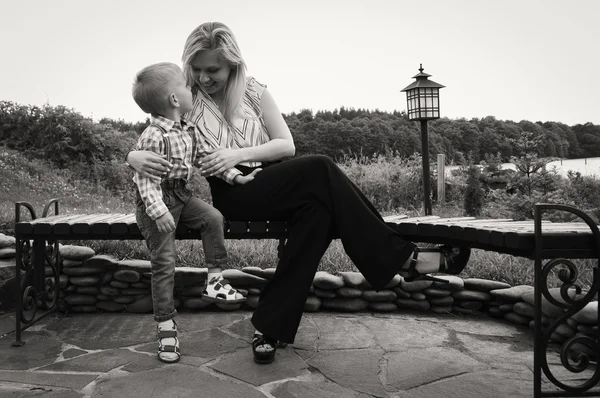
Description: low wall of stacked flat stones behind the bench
xmin=8 ymin=245 xmax=580 ymax=349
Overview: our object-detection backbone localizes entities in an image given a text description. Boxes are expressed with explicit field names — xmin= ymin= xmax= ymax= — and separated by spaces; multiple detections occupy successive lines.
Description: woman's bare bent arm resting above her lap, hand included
xmin=201 ymin=89 xmax=296 ymax=175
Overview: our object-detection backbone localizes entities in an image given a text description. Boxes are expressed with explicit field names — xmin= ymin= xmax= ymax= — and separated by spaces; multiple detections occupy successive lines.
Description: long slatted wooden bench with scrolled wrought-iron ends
xmin=10 ymin=199 xmax=600 ymax=397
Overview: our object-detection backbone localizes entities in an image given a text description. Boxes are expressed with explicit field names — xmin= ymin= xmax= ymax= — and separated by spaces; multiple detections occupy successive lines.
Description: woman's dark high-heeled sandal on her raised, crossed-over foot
xmin=399 ymin=245 xmax=471 ymax=283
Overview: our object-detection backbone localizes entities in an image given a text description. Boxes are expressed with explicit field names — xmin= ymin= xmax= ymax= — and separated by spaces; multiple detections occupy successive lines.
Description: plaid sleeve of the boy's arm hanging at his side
xmin=133 ymin=127 xmax=169 ymax=220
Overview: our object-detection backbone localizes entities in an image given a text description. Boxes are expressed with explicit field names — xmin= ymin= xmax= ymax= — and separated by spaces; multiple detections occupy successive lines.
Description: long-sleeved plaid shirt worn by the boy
xmin=133 ymin=116 xmax=242 ymax=220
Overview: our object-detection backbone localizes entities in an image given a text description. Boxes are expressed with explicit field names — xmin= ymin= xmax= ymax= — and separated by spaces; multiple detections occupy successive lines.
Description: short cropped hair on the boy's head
xmin=131 ymin=62 xmax=183 ymax=114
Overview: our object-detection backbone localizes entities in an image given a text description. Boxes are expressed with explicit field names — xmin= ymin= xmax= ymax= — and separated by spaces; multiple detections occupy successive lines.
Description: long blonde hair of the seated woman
xmin=181 ymin=22 xmax=246 ymax=123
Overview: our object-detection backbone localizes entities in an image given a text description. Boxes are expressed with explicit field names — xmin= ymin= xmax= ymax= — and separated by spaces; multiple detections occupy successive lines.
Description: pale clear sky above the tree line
xmin=0 ymin=0 xmax=600 ymax=126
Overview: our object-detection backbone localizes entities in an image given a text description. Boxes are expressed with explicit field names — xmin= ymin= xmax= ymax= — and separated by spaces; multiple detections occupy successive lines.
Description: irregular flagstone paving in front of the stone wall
xmin=0 ymin=311 xmax=589 ymax=398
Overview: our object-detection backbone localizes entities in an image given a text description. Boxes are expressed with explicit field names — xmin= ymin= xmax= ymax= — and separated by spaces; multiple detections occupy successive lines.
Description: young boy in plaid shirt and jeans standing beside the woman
xmin=132 ymin=62 xmax=254 ymax=363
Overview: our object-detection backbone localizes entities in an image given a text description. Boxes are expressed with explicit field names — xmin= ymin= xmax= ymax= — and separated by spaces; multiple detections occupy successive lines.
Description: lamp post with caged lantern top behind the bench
xmin=401 ymin=64 xmax=445 ymax=216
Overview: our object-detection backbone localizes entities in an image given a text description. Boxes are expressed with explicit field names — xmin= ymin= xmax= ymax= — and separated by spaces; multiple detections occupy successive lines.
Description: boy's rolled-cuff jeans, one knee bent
xmin=136 ymin=179 xmax=227 ymax=322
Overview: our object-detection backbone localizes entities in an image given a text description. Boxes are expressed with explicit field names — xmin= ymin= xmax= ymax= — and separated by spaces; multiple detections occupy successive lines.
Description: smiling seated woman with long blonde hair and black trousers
xmin=127 ymin=22 xmax=469 ymax=363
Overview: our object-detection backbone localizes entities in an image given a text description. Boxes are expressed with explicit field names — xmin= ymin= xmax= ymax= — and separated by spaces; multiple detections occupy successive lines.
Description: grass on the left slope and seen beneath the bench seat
xmin=0 ymin=147 xmax=592 ymax=286
